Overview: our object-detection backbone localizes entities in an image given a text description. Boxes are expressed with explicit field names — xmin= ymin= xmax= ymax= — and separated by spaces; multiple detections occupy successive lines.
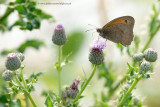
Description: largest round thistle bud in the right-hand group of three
xmin=144 ymin=48 xmax=157 ymax=62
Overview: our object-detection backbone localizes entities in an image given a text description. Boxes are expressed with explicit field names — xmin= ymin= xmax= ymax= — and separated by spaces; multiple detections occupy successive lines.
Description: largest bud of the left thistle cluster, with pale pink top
xmin=5 ymin=53 xmax=21 ymax=71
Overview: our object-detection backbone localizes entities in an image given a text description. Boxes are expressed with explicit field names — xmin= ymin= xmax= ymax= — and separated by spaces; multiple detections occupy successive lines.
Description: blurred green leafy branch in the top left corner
xmin=0 ymin=0 xmax=54 ymax=32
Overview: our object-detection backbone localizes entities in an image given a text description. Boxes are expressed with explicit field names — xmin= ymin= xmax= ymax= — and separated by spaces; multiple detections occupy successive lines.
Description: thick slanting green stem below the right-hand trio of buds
xmin=118 ymin=75 xmax=142 ymax=107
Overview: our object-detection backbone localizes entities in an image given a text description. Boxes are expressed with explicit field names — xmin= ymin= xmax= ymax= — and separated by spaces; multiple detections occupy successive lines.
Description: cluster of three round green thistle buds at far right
xmin=133 ymin=48 xmax=158 ymax=72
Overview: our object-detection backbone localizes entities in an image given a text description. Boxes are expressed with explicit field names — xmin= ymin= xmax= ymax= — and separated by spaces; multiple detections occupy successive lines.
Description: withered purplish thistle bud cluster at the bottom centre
xmin=61 ymin=79 xmax=80 ymax=104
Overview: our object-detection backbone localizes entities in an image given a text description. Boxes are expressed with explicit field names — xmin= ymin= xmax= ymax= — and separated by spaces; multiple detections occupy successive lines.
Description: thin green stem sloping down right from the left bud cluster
xmin=14 ymin=71 xmax=37 ymax=107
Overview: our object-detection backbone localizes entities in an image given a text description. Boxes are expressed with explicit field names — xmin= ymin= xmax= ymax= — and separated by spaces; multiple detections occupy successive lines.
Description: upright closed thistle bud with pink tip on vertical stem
xmin=52 ymin=25 xmax=66 ymax=45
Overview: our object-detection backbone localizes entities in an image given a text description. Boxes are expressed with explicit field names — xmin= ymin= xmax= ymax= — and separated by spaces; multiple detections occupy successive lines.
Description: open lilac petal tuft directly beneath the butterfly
xmin=92 ymin=38 xmax=106 ymax=50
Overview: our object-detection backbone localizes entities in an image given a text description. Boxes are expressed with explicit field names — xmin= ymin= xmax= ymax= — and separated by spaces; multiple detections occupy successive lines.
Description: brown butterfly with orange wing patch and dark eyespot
xmin=96 ymin=16 xmax=135 ymax=46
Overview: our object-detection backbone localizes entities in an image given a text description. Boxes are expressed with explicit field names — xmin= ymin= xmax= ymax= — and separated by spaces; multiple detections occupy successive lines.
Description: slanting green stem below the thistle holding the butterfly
xmin=73 ymin=65 xmax=96 ymax=103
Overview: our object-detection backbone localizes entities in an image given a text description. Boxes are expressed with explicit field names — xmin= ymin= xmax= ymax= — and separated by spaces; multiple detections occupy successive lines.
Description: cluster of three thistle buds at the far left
xmin=2 ymin=53 xmax=24 ymax=81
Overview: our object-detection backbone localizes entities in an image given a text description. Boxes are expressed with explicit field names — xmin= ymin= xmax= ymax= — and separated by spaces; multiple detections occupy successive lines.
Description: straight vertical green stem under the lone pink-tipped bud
xmin=57 ymin=46 xmax=62 ymax=96
